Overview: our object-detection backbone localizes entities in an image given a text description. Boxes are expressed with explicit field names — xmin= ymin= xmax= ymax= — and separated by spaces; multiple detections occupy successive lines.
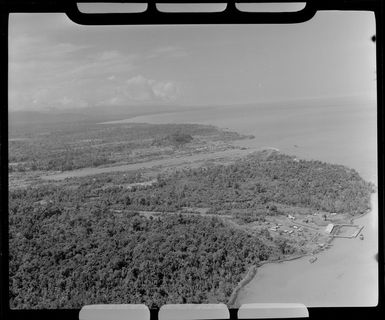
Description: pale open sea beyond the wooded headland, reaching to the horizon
xmin=108 ymin=98 xmax=377 ymax=184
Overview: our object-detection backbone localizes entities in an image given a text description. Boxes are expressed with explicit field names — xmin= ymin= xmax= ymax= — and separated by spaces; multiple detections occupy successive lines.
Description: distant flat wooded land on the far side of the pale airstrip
xmin=9 ymin=122 xmax=250 ymax=172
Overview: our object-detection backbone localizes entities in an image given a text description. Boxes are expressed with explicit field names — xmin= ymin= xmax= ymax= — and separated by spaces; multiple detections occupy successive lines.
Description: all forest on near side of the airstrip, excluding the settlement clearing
xmin=9 ymin=150 xmax=373 ymax=308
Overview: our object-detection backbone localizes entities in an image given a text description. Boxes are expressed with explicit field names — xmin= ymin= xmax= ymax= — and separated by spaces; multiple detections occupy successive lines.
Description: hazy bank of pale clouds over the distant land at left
xmin=9 ymin=34 xmax=180 ymax=110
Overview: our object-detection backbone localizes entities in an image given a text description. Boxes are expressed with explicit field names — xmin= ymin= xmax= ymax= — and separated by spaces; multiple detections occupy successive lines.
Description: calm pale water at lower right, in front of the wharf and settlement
xmin=235 ymin=193 xmax=378 ymax=307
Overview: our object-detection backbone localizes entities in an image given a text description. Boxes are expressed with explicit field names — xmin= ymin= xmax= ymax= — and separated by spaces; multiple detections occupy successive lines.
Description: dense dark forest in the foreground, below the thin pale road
xmin=10 ymin=210 xmax=277 ymax=308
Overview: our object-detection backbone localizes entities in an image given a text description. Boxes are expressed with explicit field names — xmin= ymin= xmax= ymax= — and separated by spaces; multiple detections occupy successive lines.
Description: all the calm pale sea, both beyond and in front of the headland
xmin=106 ymin=99 xmax=378 ymax=307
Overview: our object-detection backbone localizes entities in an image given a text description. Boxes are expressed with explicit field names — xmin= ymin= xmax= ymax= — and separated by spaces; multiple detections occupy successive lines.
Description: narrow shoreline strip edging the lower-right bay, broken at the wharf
xmin=226 ymin=189 xmax=378 ymax=308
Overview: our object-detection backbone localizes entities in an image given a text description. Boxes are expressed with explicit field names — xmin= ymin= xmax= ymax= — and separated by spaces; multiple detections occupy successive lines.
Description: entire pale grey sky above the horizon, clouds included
xmin=9 ymin=11 xmax=376 ymax=111
